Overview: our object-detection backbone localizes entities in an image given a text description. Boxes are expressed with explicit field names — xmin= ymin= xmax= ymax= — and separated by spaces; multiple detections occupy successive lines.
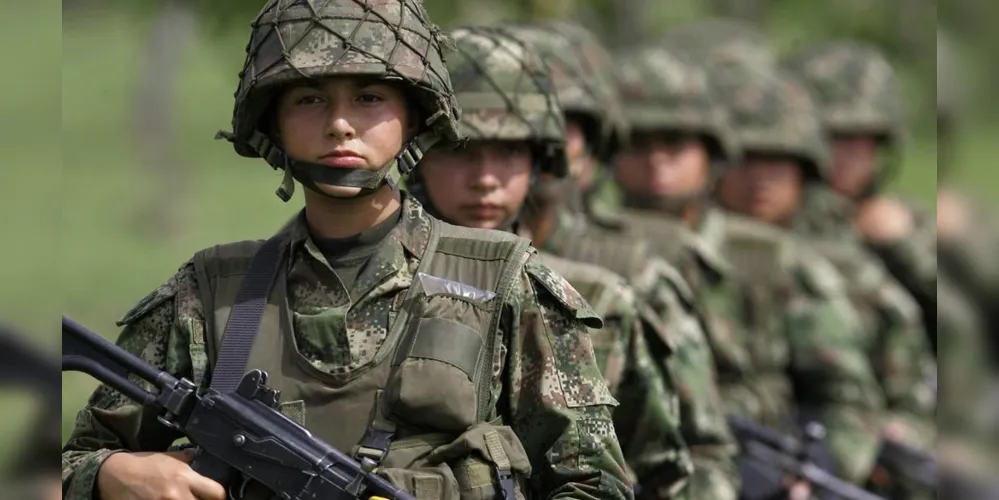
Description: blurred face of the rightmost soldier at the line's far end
xmin=832 ymin=134 xmax=878 ymax=198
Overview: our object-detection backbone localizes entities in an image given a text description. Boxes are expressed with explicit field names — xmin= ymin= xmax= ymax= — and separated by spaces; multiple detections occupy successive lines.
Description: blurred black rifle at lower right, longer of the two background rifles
xmin=727 ymin=415 xmax=885 ymax=500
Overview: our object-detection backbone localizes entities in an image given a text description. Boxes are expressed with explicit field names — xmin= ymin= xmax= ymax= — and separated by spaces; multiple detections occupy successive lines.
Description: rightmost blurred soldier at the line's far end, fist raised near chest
xmin=785 ymin=41 xmax=937 ymax=343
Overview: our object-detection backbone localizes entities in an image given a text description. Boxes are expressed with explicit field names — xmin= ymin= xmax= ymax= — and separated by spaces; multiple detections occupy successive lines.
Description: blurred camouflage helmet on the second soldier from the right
xmin=712 ymin=67 xmax=830 ymax=181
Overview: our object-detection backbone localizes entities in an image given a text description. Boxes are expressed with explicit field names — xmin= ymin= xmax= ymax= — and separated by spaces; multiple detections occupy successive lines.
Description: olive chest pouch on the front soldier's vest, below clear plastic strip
xmin=385 ymin=294 xmax=500 ymax=435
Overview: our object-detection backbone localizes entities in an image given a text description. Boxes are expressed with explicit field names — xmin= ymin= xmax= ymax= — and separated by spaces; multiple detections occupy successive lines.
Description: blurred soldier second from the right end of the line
xmin=712 ymin=63 xmax=936 ymax=496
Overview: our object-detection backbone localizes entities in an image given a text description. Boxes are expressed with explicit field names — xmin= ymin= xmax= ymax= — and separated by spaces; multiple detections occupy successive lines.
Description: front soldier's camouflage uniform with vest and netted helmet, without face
xmin=62 ymin=0 xmax=632 ymax=499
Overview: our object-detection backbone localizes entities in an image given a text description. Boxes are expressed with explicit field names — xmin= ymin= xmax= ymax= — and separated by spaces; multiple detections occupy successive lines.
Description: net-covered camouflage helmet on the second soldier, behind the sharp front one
xmin=447 ymin=27 xmax=568 ymax=177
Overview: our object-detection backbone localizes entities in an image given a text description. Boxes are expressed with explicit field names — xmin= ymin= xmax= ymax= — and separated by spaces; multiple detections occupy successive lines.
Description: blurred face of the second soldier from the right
xmin=736 ymin=154 xmax=803 ymax=225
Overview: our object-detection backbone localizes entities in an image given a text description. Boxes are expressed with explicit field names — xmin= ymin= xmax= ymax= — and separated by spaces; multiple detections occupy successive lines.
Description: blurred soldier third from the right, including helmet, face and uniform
xmin=615 ymin=48 xmax=883 ymax=496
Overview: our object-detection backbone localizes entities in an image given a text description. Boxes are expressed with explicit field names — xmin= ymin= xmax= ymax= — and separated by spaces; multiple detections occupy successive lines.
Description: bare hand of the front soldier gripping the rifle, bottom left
xmin=97 ymin=450 xmax=226 ymax=500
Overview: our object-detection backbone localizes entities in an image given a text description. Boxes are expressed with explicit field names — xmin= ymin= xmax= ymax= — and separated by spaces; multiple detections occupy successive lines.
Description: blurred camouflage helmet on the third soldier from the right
xmin=618 ymin=47 xmax=739 ymax=162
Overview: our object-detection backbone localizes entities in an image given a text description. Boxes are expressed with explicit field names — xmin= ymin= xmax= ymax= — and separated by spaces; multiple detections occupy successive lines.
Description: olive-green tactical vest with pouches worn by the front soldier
xmin=194 ymin=219 xmax=533 ymax=500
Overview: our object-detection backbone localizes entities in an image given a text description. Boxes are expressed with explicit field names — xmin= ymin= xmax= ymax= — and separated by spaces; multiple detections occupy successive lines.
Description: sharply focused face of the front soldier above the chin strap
xmin=277 ymin=77 xmax=409 ymax=197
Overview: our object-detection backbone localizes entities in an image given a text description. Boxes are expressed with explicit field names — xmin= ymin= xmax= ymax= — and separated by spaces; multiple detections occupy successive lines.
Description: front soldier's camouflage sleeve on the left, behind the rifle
xmin=62 ymin=265 xmax=200 ymax=500
